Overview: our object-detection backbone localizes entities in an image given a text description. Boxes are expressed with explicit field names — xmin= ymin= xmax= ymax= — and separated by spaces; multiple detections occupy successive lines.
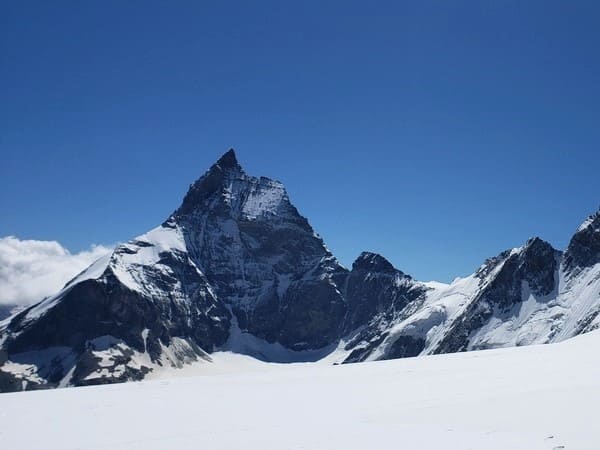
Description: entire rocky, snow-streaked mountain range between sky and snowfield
xmin=0 ymin=150 xmax=600 ymax=391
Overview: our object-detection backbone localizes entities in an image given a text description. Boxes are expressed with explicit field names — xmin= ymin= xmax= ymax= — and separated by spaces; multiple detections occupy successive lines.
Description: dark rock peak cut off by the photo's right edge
xmin=564 ymin=211 xmax=600 ymax=273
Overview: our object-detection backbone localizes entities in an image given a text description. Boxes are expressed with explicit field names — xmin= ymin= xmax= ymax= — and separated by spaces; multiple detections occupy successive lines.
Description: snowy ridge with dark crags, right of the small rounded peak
xmin=346 ymin=213 xmax=600 ymax=361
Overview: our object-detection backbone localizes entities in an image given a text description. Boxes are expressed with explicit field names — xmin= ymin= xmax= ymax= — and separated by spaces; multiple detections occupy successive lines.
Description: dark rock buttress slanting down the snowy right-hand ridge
xmin=434 ymin=238 xmax=560 ymax=353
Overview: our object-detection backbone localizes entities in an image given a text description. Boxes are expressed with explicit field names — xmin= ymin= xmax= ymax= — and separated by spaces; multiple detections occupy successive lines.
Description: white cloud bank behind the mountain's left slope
xmin=0 ymin=236 xmax=111 ymax=306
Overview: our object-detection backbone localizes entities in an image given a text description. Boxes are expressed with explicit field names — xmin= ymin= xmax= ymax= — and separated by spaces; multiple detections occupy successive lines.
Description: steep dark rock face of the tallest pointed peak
xmin=170 ymin=151 xmax=346 ymax=350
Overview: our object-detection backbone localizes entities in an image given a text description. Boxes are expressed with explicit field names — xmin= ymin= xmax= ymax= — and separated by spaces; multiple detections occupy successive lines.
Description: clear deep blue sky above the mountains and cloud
xmin=0 ymin=1 xmax=600 ymax=280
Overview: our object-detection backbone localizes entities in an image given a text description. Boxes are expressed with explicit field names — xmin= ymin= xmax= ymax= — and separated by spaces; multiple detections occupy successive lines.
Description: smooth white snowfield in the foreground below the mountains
xmin=0 ymin=332 xmax=600 ymax=450
